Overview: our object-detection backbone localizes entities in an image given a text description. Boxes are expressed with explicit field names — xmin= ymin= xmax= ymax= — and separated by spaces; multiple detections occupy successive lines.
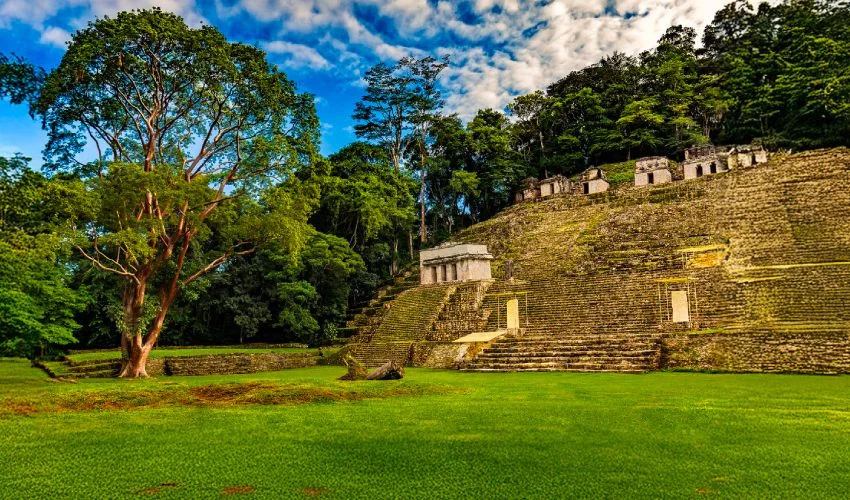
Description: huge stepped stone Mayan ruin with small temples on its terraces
xmin=349 ymin=147 xmax=850 ymax=373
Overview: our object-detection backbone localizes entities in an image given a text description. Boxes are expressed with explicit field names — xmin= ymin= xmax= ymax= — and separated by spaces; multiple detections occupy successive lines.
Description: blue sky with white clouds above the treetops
xmin=0 ymin=0 xmax=740 ymax=158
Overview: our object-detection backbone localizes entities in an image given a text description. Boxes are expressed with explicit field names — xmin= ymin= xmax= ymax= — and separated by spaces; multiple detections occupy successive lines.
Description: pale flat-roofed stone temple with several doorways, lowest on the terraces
xmin=419 ymin=242 xmax=493 ymax=285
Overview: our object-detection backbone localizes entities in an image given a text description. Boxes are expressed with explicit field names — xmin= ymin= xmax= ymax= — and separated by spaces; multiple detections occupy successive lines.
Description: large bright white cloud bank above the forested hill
xmin=229 ymin=0 xmax=778 ymax=118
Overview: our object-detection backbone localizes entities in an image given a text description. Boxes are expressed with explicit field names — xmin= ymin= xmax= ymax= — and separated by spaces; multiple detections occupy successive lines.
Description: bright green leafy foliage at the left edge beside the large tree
xmin=0 ymin=157 xmax=86 ymax=357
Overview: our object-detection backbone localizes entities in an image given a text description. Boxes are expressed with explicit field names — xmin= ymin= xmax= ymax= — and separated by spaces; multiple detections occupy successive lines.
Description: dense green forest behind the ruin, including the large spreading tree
xmin=0 ymin=0 xmax=850 ymax=362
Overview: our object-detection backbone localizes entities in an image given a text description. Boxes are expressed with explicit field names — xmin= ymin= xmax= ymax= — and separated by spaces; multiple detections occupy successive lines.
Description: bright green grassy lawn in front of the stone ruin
xmin=0 ymin=360 xmax=850 ymax=499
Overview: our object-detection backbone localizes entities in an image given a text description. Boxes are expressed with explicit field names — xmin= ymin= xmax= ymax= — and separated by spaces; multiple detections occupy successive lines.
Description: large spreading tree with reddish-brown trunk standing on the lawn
xmin=5 ymin=9 xmax=318 ymax=377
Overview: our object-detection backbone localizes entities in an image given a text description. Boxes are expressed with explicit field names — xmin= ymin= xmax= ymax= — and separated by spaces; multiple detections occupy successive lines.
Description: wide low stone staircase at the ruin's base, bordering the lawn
xmin=462 ymin=334 xmax=661 ymax=373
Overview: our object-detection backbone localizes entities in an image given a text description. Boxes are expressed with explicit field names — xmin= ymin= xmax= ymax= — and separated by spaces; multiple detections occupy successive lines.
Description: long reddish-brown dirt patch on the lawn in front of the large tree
xmin=0 ymin=382 xmax=440 ymax=416
